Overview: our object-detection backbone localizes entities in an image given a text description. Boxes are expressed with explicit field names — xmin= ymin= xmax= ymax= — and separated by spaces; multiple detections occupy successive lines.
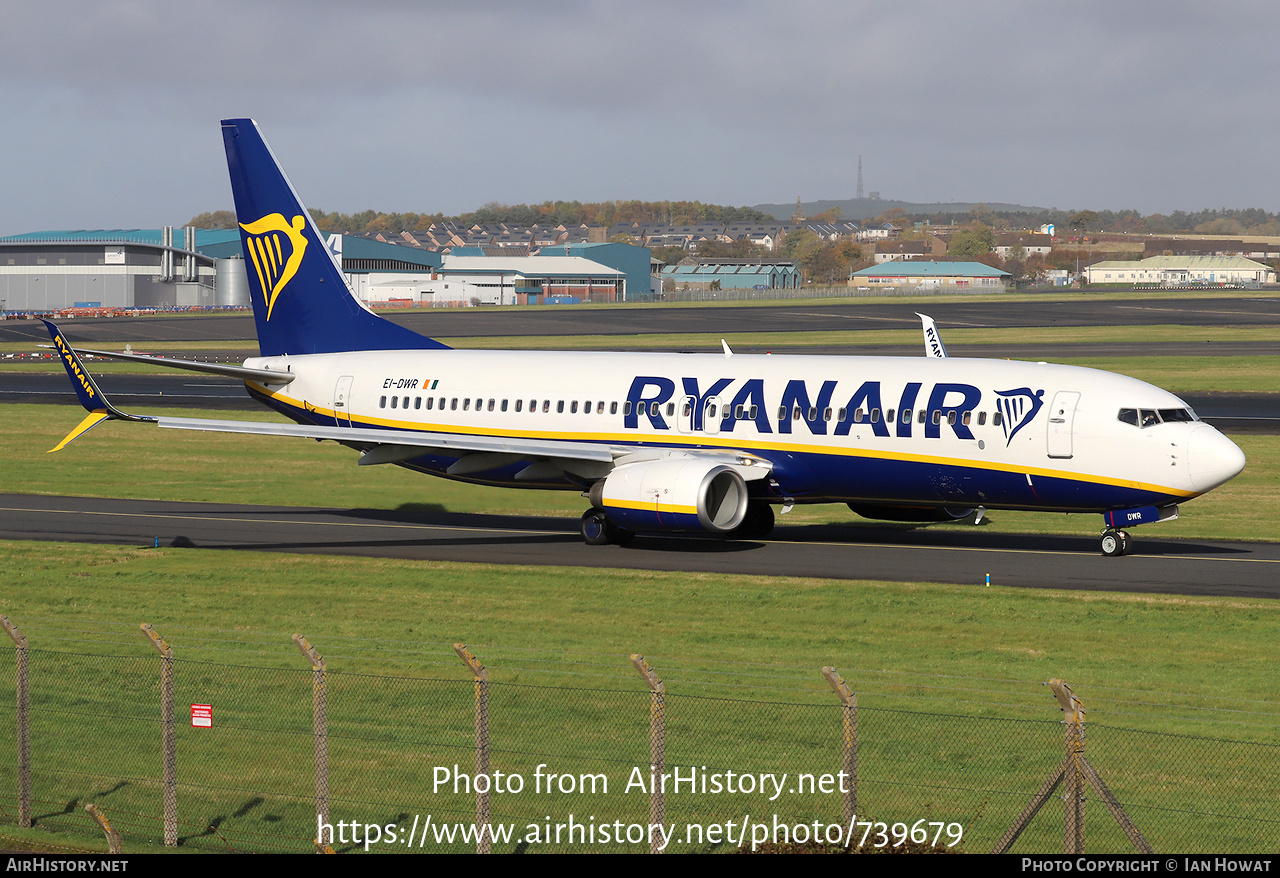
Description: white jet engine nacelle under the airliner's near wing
xmin=588 ymin=458 xmax=746 ymax=534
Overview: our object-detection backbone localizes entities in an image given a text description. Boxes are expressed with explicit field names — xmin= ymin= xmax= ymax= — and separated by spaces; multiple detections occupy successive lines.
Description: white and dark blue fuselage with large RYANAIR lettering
xmin=238 ymin=349 xmax=1244 ymax=512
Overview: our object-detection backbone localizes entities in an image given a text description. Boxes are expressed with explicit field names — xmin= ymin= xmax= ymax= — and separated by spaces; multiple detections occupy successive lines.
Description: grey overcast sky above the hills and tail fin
xmin=0 ymin=0 xmax=1280 ymax=234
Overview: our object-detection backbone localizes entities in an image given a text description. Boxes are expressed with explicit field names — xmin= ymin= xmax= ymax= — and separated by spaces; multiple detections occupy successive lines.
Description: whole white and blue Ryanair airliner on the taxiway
xmin=49 ymin=119 xmax=1244 ymax=555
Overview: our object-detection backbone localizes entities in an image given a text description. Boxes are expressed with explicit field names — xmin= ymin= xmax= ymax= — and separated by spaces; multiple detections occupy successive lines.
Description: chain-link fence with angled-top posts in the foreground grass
xmin=0 ymin=619 xmax=1280 ymax=854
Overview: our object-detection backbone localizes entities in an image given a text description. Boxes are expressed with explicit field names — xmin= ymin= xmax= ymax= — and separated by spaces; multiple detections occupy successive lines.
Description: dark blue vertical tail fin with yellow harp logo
xmin=223 ymin=119 xmax=448 ymax=357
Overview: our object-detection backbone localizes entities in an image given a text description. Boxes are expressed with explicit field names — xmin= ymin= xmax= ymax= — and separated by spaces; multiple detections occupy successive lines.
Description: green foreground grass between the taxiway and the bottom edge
xmin=0 ymin=544 xmax=1280 ymax=851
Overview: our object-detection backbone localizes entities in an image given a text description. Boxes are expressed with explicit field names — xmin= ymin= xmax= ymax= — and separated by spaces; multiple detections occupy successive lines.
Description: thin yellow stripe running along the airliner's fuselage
xmin=246 ymin=381 xmax=1199 ymax=499
